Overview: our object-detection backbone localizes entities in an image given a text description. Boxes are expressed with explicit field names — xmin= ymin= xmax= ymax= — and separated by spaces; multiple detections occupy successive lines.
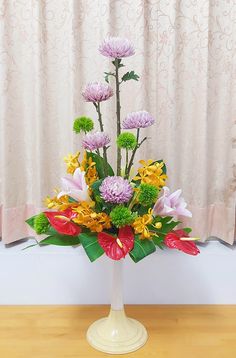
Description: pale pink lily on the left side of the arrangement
xmin=57 ymin=168 xmax=90 ymax=201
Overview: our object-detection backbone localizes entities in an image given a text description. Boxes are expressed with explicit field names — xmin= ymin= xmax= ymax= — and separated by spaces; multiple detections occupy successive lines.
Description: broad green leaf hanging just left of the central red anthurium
xmin=79 ymin=232 xmax=104 ymax=262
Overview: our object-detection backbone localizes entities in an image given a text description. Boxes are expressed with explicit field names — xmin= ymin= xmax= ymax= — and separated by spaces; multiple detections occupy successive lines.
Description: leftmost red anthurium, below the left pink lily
xmin=44 ymin=208 xmax=81 ymax=236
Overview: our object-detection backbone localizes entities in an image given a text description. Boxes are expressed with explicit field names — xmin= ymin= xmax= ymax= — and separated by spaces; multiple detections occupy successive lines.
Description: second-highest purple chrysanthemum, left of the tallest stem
xmin=82 ymin=82 xmax=113 ymax=102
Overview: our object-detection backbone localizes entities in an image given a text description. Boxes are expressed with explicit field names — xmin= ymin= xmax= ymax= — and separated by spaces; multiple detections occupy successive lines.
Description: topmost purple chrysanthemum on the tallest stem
xmin=99 ymin=37 xmax=135 ymax=58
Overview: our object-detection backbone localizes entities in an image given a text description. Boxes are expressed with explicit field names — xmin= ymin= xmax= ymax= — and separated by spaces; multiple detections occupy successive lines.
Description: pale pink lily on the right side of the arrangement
xmin=153 ymin=186 xmax=192 ymax=217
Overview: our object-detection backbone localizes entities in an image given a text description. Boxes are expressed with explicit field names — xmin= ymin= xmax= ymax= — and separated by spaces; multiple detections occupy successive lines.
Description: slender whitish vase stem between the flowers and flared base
xmin=111 ymin=259 xmax=124 ymax=311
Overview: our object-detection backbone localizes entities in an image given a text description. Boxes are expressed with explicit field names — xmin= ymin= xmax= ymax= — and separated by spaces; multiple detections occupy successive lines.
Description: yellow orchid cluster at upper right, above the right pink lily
xmin=133 ymin=159 xmax=167 ymax=189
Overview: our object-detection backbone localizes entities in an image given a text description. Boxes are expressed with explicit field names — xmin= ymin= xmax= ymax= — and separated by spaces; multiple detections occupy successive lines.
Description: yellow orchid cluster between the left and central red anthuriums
xmin=73 ymin=202 xmax=111 ymax=232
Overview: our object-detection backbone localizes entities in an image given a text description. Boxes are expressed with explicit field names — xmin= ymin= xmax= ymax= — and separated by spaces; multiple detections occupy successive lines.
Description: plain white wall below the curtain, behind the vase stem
xmin=0 ymin=241 xmax=236 ymax=304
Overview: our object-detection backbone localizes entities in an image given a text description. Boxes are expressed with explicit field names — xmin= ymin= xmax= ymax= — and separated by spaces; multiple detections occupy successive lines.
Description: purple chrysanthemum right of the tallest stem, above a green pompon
xmin=122 ymin=111 xmax=155 ymax=129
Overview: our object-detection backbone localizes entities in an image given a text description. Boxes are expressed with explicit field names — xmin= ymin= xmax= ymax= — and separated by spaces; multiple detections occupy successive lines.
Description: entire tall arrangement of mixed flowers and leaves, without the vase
xmin=26 ymin=37 xmax=199 ymax=262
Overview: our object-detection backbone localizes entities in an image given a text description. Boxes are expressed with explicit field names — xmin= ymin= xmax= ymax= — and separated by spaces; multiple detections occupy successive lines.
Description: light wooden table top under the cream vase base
xmin=0 ymin=305 xmax=236 ymax=358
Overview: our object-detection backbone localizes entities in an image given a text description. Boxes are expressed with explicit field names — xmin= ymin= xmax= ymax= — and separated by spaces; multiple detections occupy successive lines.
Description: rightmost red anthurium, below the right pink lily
xmin=164 ymin=230 xmax=200 ymax=255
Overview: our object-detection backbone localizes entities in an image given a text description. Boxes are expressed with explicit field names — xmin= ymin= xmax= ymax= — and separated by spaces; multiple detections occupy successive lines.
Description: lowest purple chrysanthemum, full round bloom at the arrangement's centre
xmin=99 ymin=176 xmax=133 ymax=204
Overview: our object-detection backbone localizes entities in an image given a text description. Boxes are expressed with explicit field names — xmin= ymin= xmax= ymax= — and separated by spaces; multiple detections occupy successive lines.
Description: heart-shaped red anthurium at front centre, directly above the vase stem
xmin=98 ymin=226 xmax=134 ymax=260
